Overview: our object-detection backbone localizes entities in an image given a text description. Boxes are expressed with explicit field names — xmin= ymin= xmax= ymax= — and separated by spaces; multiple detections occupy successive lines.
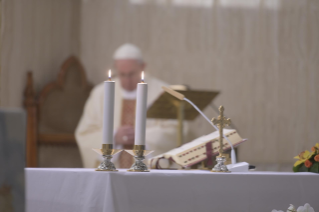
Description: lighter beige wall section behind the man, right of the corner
xmin=81 ymin=0 xmax=319 ymax=170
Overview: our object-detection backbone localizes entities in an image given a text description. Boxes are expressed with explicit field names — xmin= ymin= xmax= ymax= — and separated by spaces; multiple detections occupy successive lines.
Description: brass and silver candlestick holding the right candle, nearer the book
xmin=125 ymin=145 xmax=153 ymax=172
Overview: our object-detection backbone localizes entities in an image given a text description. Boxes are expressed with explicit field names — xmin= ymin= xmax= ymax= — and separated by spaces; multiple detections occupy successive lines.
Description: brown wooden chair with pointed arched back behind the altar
xmin=24 ymin=56 xmax=92 ymax=167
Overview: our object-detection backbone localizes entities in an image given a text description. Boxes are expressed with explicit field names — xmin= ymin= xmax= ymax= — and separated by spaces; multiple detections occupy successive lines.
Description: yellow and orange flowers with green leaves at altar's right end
xmin=293 ymin=143 xmax=319 ymax=173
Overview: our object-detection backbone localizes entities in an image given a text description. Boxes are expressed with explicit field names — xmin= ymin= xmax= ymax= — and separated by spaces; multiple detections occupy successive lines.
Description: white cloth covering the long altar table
xmin=26 ymin=168 xmax=319 ymax=212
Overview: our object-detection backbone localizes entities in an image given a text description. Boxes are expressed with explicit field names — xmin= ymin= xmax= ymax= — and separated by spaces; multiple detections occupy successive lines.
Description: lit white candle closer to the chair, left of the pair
xmin=102 ymin=70 xmax=115 ymax=144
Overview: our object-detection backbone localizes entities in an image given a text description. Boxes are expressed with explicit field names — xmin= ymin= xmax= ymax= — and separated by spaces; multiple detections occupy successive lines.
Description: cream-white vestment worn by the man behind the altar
xmin=75 ymin=75 xmax=185 ymax=168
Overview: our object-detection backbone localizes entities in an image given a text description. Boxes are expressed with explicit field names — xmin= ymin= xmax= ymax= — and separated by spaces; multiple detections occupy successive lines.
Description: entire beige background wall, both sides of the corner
xmin=0 ymin=0 xmax=319 ymax=170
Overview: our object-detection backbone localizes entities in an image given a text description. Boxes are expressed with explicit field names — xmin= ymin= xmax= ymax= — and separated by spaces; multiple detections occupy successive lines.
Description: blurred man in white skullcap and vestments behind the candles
xmin=76 ymin=44 xmax=177 ymax=168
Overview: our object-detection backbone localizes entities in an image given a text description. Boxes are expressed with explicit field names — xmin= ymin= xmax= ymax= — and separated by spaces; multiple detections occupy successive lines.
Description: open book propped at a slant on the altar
xmin=150 ymin=129 xmax=247 ymax=169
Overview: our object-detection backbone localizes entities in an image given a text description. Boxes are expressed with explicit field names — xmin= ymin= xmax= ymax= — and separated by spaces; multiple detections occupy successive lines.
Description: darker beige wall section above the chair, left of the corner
xmin=0 ymin=0 xmax=81 ymax=107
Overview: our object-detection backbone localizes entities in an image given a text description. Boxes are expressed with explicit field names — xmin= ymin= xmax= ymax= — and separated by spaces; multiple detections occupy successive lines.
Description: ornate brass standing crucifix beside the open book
xmin=212 ymin=106 xmax=231 ymax=172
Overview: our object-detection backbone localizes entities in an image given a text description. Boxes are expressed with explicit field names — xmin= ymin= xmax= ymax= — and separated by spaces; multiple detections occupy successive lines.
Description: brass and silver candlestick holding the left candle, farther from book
xmin=93 ymin=144 xmax=123 ymax=171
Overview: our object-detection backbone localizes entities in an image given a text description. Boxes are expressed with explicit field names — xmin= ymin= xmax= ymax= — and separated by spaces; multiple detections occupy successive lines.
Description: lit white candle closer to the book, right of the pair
xmin=135 ymin=72 xmax=147 ymax=145
